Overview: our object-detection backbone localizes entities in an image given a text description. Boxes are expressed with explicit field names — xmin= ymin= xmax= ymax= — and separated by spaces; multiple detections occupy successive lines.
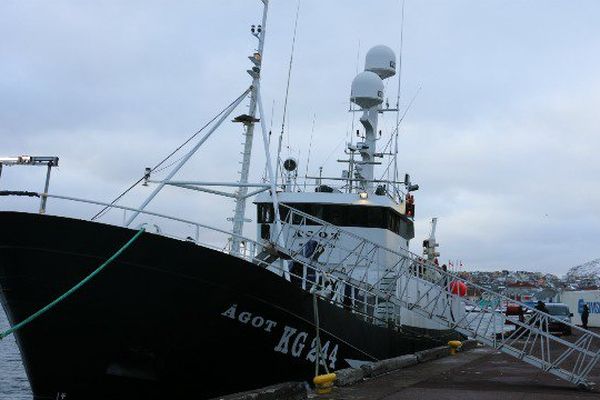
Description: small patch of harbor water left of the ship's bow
xmin=0 ymin=307 xmax=32 ymax=400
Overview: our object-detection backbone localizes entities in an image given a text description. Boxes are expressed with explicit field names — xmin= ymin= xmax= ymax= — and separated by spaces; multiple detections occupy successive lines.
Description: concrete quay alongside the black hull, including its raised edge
xmin=215 ymin=330 xmax=600 ymax=400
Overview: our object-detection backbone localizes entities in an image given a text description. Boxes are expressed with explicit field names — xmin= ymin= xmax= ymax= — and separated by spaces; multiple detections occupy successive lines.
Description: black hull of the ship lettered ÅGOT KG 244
xmin=0 ymin=212 xmax=455 ymax=400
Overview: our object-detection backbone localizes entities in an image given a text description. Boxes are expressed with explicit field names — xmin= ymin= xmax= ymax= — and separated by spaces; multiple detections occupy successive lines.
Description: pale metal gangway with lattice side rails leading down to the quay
xmin=270 ymin=205 xmax=600 ymax=387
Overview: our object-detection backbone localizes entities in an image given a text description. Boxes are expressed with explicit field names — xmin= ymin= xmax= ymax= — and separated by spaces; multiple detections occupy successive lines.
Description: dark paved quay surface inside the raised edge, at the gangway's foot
xmin=321 ymin=330 xmax=600 ymax=400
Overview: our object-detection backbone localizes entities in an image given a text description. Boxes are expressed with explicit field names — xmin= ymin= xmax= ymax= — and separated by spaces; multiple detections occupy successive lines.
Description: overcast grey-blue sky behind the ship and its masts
xmin=0 ymin=0 xmax=600 ymax=274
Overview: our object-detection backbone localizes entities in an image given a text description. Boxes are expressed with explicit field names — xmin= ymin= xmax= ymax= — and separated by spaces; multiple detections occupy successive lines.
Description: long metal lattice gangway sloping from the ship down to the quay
xmin=259 ymin=204 xmax=600 ymax=388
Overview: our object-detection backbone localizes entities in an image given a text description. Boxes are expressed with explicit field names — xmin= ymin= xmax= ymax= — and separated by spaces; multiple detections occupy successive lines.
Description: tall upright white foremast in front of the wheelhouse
xmin=231 ymin=0 xmax=269 ymax=254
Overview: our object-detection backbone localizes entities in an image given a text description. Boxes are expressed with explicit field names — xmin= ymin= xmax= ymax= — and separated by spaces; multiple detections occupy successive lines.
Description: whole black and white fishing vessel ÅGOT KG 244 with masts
xmin=0 ymin=0 xmax=464 ymax=400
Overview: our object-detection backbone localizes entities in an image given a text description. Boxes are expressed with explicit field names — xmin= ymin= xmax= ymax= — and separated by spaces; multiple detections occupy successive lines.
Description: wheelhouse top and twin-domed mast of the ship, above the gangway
xmin=254 ymin=46 xmax=415 ymax=276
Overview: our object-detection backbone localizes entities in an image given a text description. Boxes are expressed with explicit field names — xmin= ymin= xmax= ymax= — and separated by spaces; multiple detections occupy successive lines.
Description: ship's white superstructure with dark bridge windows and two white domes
xmin=254 ymin=46 xmax=462 ymax=329
